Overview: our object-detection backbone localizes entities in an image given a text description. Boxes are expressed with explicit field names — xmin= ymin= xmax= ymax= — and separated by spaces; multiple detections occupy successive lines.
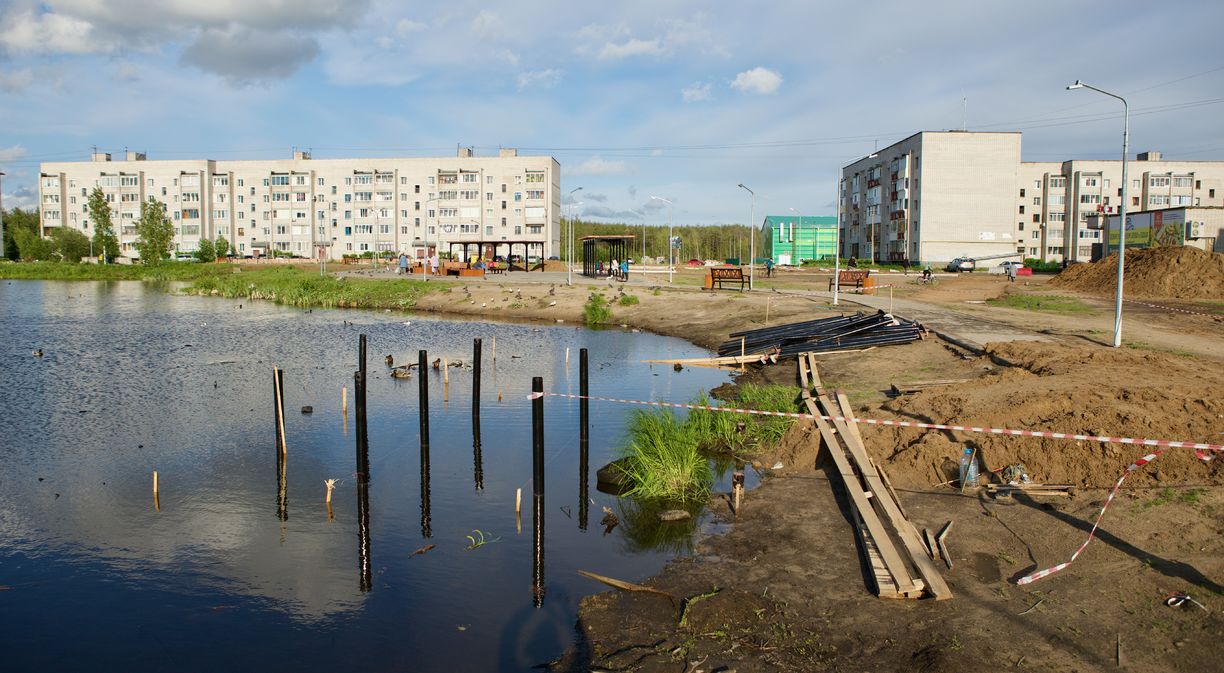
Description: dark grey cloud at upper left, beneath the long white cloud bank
xmin=181 ymin=27 xmax=319 ymax=83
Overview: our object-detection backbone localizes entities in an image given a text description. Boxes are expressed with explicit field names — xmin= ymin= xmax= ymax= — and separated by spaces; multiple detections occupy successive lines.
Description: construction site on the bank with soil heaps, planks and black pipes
xmin=523 ymin=248 xmax=1224 ymax=672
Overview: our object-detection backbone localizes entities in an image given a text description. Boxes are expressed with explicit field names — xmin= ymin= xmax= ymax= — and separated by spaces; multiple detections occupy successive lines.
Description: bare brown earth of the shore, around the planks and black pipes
xmin=357 ymin=264 xmax=1224 ymax=672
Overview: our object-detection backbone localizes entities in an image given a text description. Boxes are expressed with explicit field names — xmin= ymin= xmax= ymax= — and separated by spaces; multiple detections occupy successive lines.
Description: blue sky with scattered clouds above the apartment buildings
xmin=0 ymin=0 xmax=1224 ymax=224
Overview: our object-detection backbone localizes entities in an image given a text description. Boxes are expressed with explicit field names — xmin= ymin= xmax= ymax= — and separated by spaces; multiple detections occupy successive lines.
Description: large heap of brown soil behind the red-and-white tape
xmin=862 ymin=341 xmax=1224 ymax=488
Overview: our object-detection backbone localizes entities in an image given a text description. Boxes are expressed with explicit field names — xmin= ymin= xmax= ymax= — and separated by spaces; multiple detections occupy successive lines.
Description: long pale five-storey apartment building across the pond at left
xmin=39 ymin=148 xmax=561 ymax=259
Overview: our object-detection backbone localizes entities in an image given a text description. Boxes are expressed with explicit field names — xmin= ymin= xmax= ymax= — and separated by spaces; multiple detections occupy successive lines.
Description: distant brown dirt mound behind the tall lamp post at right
xmin=1050 ymin=246 xmax=1224 ymax=299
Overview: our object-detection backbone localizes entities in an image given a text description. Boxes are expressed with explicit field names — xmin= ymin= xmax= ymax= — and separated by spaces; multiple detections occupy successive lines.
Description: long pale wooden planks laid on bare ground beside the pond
xmin=799 ymin=354 xmax=952 ymax=600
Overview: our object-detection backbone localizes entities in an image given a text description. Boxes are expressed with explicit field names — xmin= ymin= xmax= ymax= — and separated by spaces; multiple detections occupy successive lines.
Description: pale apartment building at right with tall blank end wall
xmin=838 ymin=131 xmax=1224 ymax=263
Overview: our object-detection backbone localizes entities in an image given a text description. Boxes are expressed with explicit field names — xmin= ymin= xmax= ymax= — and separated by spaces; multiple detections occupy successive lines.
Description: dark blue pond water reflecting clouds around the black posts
xmin=0 ymin=281 xmax=727 ymax=672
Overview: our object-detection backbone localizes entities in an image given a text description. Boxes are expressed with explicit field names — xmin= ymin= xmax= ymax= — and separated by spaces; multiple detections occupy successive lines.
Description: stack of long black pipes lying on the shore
xmin=718 ymin=311 xmax=927 ymax=357
